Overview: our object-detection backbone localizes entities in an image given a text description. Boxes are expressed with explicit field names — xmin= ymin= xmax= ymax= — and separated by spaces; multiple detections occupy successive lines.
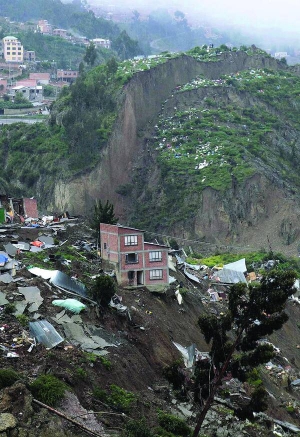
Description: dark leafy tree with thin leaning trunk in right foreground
xmin=193 ymin=269 xmax=296 ymax=437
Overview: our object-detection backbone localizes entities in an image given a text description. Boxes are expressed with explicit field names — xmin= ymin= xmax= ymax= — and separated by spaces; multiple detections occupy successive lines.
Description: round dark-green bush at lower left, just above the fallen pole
xmin=29 ymin=375 xmax=67 ymax=407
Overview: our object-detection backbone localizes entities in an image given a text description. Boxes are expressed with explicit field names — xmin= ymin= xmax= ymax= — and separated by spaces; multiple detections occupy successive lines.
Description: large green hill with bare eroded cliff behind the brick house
xmin=0 ymin=47 xmax=300 ymax=255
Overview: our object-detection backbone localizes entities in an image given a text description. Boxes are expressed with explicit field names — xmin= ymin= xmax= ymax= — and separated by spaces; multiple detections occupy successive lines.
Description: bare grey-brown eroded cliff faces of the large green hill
xmin=49 ymin=52 xmax=299 ymax=251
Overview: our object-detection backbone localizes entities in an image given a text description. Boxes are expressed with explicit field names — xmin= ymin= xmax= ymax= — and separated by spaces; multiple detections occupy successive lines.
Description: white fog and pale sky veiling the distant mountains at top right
xmin=81 ymin=0 xmax=300 ymax=56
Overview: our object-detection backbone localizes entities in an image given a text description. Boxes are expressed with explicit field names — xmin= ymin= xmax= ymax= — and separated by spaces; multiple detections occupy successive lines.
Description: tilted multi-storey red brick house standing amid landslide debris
xmin=100 ymin=223 xmax=169 ymax=286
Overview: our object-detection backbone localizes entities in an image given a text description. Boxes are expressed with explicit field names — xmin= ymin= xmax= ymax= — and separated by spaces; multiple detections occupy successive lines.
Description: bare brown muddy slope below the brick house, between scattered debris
xmin=0 ymin=223 xmax=300 ymax=437
